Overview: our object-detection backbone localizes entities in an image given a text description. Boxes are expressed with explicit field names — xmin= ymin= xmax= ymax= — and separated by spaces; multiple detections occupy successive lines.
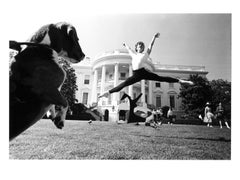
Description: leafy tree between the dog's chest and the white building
xmin=59 ymin=57 xmax=78 ymax=113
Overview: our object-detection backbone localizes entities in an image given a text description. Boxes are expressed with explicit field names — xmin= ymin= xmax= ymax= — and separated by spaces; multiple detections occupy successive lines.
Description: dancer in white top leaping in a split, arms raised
xmin=98 ymin=33 xmax=193 ymax=98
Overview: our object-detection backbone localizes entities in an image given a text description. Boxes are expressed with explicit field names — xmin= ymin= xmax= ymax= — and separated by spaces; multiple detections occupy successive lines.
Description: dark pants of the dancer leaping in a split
xmin=109 ymin=68 xmax=179 ymax=93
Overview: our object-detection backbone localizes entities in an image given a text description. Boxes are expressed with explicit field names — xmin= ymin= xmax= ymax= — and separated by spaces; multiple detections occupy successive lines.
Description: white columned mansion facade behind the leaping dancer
xmin=73 ymin=49 xmax=208 ymax=121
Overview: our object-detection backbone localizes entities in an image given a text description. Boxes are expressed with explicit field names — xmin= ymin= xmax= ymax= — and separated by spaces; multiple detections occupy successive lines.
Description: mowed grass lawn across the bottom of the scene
xmin=9 ymin=120 xmax=231 ymax=160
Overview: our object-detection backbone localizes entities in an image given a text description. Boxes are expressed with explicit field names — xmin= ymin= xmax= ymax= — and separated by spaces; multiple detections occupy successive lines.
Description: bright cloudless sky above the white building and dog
xmin=9 ymin=13 xmax=231 ymax=81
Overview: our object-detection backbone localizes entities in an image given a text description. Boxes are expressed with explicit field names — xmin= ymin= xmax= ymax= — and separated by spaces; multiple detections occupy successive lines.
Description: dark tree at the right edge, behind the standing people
xmin=210 ymin=79 xmax=231 ymax=119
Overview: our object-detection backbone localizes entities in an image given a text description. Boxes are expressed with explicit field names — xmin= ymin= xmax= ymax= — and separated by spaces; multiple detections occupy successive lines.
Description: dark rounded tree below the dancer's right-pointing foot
xmin=179 ymin=75 xmax=213 ymax=115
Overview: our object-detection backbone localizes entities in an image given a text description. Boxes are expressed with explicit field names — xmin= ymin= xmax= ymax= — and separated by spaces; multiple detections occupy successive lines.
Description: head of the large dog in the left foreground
xmin=30 ymin=22 xmax=85 ymax=63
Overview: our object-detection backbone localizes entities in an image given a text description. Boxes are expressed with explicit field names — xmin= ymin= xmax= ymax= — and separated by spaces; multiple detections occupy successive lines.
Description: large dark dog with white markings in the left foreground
xmin=10 ymin=23 xmax=85 ymax=140
